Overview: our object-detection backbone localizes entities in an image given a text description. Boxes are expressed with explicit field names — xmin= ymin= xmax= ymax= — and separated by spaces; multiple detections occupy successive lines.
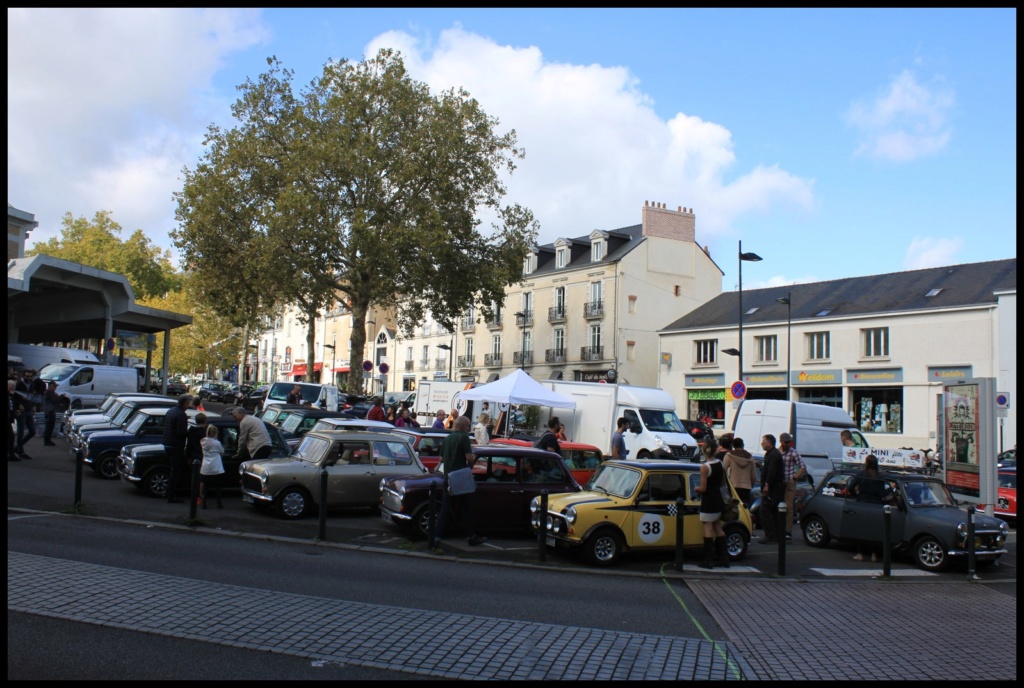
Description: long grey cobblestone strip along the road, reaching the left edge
xmin=7 ymin=552 xmax=757 ymax=680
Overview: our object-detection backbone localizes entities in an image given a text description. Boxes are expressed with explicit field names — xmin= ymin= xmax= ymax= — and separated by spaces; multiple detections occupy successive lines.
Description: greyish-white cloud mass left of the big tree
xmin=7 ymin=8 xmax=266 ymax=247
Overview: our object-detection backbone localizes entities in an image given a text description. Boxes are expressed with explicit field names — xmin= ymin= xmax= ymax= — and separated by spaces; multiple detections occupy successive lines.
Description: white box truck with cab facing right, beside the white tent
xmin=541 ymin=380 xmax=698 ymax=460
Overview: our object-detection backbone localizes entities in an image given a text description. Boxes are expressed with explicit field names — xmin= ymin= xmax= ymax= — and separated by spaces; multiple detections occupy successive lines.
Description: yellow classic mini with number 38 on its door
xmin=530 ymin=459 xmax=752 ymax=566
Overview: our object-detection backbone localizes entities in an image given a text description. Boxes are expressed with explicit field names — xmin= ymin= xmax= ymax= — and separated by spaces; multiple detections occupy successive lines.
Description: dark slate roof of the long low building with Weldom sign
xmin=659 ymin=258 xmax=1017 ymax=333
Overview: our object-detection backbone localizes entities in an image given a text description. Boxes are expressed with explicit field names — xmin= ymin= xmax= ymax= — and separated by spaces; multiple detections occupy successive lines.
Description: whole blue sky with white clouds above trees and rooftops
xmin=7 ymin=8 xmax=1017 ymax=290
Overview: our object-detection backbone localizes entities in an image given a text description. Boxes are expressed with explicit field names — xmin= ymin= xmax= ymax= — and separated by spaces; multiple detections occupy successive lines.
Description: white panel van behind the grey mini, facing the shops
xmin=732 ymin=399 xmax=868 ymax=484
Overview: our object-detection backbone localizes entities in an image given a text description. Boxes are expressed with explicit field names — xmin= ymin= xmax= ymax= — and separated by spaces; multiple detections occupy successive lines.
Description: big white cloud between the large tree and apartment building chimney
xmin=366 ymin=28 xmax=813 ymax=244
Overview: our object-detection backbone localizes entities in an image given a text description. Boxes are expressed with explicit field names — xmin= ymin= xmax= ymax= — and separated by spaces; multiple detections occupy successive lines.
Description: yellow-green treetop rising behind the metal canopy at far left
xmin=26 ymin=210 xmax=179 ymax=298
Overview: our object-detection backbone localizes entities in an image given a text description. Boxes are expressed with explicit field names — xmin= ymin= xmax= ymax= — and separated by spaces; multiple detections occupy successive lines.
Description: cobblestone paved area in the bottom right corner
xmin=689 ymin=581 xmax=1017 ymax=681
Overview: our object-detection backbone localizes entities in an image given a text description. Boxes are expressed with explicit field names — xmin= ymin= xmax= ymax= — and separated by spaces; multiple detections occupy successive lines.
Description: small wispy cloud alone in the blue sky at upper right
xmin=846 ymin=71 xmax=955 ymax=162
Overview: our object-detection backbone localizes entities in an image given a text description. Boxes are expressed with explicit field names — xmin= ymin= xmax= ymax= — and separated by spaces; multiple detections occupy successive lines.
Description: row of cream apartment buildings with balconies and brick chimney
xmin=258 ymin=202 xmax=723 ymax=392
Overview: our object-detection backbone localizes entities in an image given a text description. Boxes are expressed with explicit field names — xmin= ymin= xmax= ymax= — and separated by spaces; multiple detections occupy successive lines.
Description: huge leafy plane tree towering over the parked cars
xmin=175 ymin=50 xmax=537 ymax=390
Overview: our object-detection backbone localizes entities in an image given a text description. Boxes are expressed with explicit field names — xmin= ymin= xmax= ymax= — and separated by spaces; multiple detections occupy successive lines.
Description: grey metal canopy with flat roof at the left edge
xmin=7 ymin=255 xmax=193 ymax=344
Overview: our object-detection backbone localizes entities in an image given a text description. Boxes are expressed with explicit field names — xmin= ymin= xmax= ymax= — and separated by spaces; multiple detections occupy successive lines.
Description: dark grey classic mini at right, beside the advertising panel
xmin=800 ymin=469 xmax=1009 ymax=571
